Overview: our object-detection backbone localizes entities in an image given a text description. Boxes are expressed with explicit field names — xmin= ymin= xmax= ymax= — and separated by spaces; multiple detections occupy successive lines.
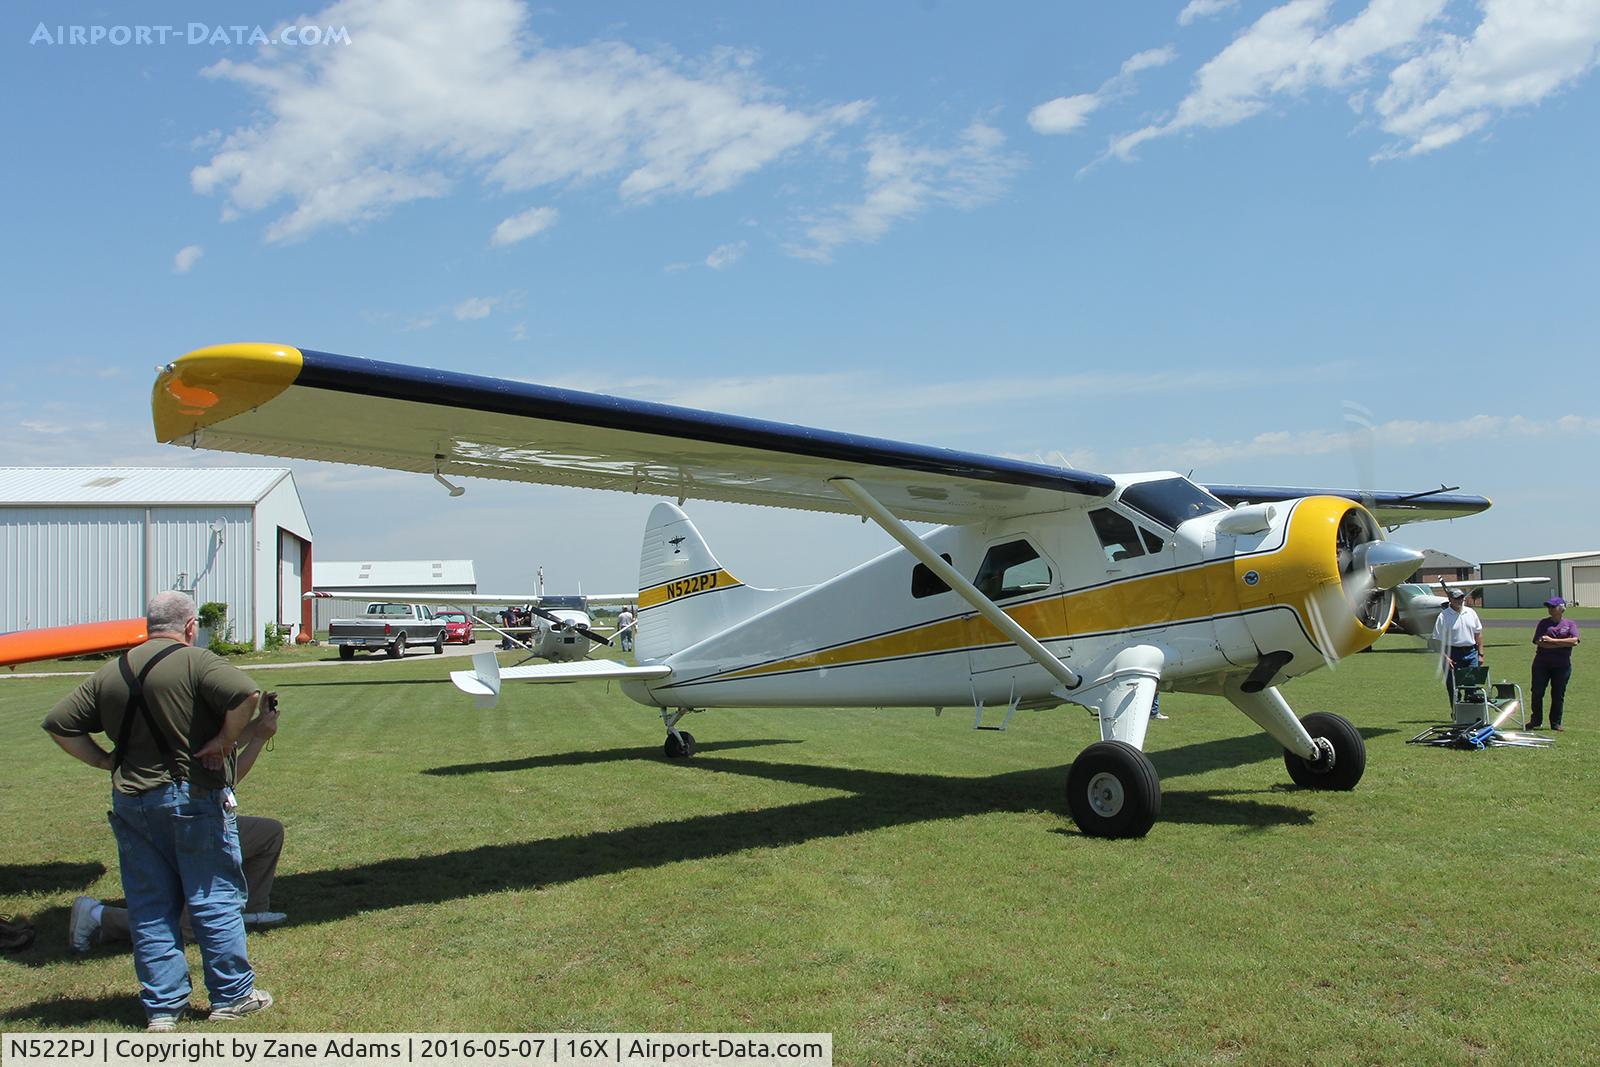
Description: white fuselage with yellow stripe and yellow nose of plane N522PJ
xmin=624 ymin=474 xmax=1387 ymax=707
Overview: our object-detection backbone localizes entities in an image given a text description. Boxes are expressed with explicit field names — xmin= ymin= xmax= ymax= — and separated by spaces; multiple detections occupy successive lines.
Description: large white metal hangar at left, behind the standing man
xmin=0 ymin=467 xmax=312 ymax=648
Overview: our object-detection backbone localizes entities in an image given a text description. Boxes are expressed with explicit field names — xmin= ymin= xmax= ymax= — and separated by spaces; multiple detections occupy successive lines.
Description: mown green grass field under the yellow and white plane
xmin=0 ymin=613 xmax=1600 ymax=1064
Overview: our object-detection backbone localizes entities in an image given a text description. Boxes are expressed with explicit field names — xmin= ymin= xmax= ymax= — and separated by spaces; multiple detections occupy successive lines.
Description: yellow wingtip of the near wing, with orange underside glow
xmin=150 ymin=344 xmax=306 ymax=445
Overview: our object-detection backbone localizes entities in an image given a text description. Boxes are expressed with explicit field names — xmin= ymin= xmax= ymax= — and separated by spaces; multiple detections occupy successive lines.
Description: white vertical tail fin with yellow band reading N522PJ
xmin=635 ymin=502 xmax=765 ymax=662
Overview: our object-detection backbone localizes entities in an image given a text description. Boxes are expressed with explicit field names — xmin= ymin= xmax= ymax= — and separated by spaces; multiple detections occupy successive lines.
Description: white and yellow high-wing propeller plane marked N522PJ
xmin=152 ymin=344 xmax=1490 ymax=837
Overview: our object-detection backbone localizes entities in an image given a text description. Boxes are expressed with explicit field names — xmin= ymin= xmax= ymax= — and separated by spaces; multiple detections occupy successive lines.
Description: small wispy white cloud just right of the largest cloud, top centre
xmin=790 ymin=122 xmax=1021 ymax=262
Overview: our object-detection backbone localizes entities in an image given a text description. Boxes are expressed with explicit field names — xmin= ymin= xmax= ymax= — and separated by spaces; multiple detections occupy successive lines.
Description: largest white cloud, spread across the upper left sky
xmin=190 ymin=0 xmax=867 ymax=242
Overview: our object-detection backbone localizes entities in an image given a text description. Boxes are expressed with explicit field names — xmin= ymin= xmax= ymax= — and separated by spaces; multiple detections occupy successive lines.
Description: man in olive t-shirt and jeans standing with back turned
xmin=43 ymin=592 xmax=272 ymax=1030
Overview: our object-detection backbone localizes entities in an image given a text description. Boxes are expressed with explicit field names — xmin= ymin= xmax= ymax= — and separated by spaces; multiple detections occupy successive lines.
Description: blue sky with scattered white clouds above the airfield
xmin=0 ymin=0 xmax=1600 ymax=590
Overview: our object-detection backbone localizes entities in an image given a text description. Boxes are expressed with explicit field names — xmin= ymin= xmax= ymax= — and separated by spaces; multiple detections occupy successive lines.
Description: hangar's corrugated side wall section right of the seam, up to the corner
xmin=150 ymin=506 xmax=254 ymax=643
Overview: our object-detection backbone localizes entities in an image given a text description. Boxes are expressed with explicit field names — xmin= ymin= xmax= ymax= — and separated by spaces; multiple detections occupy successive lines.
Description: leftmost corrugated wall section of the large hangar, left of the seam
xmin=0 ymin=507 xmax=144 ymax=630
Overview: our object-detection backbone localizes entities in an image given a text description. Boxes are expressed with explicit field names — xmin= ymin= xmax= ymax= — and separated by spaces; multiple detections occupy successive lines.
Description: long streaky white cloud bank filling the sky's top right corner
xmin=1106 ymin=0 xmax=1600 ymax=160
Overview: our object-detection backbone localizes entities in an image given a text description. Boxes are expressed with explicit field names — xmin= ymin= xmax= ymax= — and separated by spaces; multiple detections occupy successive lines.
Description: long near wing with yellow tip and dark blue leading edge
xmin=150 ymin=344 xmax=1115 ymax=523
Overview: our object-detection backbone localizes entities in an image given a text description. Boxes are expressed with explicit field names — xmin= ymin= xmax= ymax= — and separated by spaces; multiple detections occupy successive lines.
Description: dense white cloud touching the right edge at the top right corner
xmin=1376 ymin=0 xmax=1600 ymax=158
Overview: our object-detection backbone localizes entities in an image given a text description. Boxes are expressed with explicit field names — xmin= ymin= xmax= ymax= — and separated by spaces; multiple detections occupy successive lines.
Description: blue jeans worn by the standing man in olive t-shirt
xmin=107 ymin=782 xmax=256 ymax=1016
